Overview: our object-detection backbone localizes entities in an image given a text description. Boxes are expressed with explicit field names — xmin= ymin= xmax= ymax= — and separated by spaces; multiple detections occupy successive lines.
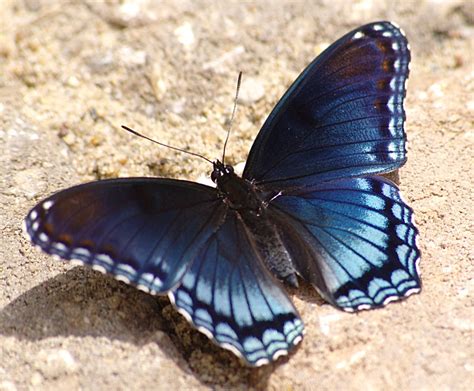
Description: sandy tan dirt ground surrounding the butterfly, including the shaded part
xmin=0 ymin=0 xmax=474 ymax=391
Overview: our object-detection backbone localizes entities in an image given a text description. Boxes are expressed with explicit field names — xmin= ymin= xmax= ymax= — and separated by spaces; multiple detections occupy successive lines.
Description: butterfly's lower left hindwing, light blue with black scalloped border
xmin=169 ymin=209 xmax=303 ymax=366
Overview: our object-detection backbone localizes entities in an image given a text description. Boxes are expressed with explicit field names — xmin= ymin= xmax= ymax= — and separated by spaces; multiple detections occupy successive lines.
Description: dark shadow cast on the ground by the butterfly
xmin=0 ymin=267 xmax=296 ymax=389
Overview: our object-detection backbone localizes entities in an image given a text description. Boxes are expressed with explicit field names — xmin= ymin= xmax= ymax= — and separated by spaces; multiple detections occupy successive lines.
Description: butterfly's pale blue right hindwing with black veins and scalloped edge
xmin=270 ymin=177 xmax=421 ymax=311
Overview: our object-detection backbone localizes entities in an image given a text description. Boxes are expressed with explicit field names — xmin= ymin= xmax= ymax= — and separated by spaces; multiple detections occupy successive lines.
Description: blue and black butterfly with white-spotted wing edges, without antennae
xmin=25 ymin=21 xmax=421 ymax=366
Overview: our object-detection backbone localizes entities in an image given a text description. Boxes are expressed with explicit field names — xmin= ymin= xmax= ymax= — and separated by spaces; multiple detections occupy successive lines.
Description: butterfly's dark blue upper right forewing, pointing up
xmin=243 ymin=22 xmax=410 ymax=187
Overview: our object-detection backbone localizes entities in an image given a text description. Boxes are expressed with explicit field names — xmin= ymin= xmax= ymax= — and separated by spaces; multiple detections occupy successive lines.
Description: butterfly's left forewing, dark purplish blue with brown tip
xmin=25 ymin=178 xmax=225 ymax=293
